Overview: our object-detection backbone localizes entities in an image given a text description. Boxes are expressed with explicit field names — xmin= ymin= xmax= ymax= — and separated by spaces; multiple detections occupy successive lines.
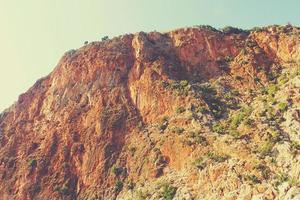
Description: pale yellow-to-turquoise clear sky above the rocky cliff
xmin=0 ymin=0 xmax=300 ymax=112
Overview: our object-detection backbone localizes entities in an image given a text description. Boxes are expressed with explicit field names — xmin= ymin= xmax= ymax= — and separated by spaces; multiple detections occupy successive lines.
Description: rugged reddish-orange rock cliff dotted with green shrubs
xmin=0 ymin=26 xmax=300 ymax=199
